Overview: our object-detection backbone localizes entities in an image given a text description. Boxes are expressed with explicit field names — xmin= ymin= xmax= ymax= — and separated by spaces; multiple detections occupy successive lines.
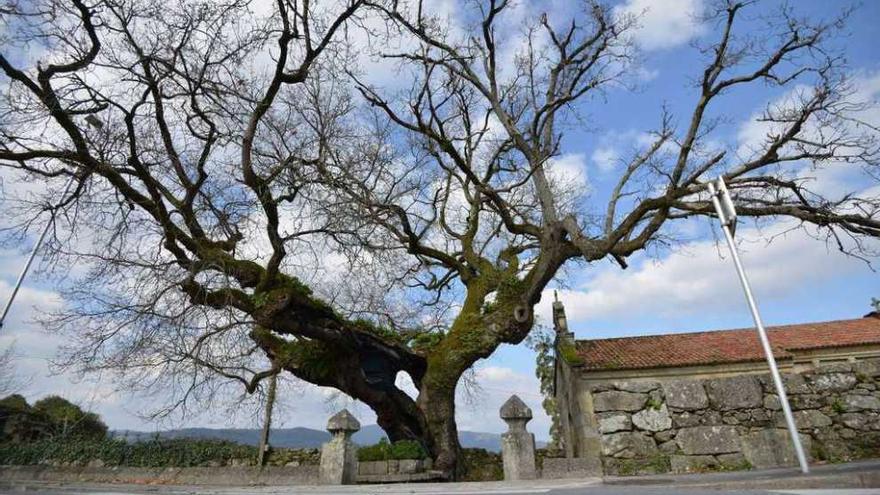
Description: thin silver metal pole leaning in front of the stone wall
xmin=708 ymin=182 xmax=810 ymax=474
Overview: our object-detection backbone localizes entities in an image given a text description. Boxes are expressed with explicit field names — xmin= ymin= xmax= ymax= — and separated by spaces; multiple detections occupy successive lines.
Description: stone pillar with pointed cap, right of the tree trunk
xmin=501 ymin=395 xmax=538 ymax=480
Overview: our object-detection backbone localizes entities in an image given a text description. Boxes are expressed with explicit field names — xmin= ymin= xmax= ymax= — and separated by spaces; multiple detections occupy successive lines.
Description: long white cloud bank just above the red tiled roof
xmin=538 ymin=221 xmax=880 ymax=328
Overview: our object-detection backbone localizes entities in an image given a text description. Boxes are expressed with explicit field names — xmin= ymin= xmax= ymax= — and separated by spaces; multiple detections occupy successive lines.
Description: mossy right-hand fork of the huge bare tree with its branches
xmin=306 ymin=0 xmax=880 ymax=469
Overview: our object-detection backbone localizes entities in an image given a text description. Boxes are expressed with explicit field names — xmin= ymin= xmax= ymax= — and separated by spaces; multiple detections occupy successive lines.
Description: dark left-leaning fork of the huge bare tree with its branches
xmin=0 ymin=0 xmax=440 ymax=458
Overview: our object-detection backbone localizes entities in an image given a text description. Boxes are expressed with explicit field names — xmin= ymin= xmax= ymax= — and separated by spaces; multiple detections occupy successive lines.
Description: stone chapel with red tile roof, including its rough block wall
xmin=553 ymin=301 xmax=880 ymax=475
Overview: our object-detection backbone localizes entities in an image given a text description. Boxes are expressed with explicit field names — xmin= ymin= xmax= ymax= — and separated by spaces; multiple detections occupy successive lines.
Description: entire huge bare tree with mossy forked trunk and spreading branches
xmin=0 ymin=0 xmax=880 ymax=476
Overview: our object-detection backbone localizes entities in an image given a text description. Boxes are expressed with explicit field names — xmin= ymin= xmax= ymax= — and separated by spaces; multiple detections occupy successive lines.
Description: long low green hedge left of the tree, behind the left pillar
xmin=0 ymin=438 xmax=318 ymax=467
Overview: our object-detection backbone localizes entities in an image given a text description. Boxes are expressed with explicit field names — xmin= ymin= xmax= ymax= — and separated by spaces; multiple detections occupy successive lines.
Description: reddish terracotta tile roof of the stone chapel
xmin=576 ymin=317 xmax=880 ymax=370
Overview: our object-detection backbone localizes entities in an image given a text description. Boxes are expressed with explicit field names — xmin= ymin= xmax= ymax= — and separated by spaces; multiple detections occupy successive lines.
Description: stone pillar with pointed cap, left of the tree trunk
xmin=321 ymin=409 xmax=361 ymax=485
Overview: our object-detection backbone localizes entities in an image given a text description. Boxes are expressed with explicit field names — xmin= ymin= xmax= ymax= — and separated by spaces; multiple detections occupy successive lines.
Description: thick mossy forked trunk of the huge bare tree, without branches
xmin=251 ymin=280 xmax=532 ymax=480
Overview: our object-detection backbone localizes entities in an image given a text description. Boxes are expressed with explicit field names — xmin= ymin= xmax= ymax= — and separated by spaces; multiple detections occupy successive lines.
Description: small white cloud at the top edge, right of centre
xmin=615 ymin=0 xmax=705 ymax=50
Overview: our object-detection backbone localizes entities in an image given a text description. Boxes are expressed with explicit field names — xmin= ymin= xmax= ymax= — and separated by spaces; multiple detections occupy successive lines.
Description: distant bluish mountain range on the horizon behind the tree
xmin=112 ymin=425 xmax=524 ymax=452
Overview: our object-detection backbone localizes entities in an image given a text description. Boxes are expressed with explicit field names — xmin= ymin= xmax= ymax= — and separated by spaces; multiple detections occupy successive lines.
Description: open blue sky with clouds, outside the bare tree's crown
xmin=0 ymin=0 xmax=880 ymax=437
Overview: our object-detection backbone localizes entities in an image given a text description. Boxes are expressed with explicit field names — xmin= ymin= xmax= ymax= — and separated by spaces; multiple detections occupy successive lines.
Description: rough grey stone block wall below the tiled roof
xmin=587 ymin=359 xmax=880 ymax=475
